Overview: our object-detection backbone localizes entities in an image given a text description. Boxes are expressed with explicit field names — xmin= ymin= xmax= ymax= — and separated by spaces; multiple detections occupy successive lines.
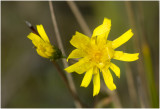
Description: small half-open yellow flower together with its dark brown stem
xmin=26 ymin=21 xmax=84 ymax=107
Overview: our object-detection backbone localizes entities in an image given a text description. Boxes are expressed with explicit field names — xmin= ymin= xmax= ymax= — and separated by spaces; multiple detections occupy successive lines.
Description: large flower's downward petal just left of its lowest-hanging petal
xmin=81 ymin=68 xmax=93 ymax=87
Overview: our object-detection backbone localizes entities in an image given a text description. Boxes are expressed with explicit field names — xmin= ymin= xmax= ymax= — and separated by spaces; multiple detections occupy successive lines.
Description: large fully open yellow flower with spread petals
xmin=65 ymin=18 xmax=139 ymax=96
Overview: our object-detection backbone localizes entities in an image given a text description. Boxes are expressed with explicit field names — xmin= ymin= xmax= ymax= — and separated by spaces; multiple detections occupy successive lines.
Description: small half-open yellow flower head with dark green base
xmin=27 ymin=25 xmax=62 ymax=60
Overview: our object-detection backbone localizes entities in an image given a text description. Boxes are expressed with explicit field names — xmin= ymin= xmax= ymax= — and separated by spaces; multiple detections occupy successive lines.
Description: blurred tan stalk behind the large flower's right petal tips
xmin=125 ymin=1 xmax=150 ymax=107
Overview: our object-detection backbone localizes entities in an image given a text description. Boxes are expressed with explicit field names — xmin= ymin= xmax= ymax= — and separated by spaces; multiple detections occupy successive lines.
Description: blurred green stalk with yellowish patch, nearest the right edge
xmin=138 ymin=2 xmax=158 ymax=108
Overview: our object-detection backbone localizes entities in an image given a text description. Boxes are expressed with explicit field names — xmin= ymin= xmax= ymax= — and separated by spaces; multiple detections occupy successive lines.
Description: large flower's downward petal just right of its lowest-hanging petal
xmin=102 ymin=67 xmax=116 ymax=90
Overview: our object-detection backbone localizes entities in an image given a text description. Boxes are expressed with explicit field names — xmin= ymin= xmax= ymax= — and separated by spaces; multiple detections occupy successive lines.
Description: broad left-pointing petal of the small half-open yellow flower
xmin=27 ymin=33 xmax=44 ymax=47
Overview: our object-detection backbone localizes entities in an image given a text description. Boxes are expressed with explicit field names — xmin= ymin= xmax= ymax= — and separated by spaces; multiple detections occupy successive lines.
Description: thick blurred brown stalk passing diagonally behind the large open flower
xmin=67 ymin=1 xmax=122 ymax=108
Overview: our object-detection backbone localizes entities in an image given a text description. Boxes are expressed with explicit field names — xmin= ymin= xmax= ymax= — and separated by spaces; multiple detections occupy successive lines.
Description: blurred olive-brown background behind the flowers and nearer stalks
xmin=1 ymin=1 xmax=159 ymax=108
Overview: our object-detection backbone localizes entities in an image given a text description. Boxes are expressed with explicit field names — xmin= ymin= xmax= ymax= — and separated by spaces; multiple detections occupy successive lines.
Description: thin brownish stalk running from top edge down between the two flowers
xmin=49 ymin=1 xmax=83 ymax=108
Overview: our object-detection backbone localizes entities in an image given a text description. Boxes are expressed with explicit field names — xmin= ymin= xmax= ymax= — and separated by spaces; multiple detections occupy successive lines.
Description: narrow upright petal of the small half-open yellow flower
xmin=37 ymin=25 xmax=50 ymax=43
